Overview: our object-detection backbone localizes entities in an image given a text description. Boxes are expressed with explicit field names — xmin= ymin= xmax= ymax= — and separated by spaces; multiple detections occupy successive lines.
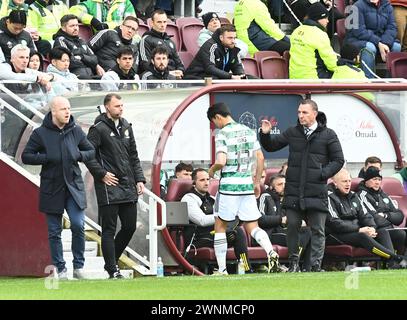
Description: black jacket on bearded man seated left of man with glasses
xmin=53 ymin=29 xmax=98 ymax=79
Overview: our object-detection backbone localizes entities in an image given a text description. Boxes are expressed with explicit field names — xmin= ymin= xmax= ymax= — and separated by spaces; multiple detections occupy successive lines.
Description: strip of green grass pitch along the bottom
xmin=0 ymin=270 xmax=407 ymax=300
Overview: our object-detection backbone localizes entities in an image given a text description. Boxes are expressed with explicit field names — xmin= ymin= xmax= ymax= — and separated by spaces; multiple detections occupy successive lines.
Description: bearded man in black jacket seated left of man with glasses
xmin=54 ymin=14 xmax=105 ymax=79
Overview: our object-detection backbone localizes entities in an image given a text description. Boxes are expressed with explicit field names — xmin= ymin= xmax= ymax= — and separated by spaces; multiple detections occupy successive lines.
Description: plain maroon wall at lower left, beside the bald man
xmin=0 ymin=160 xmax=51 ymax=277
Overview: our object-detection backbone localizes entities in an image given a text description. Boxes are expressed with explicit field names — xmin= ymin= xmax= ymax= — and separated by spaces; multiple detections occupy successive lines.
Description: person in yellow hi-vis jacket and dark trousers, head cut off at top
xmin=234 ymin=0 xmax=290 ymax=55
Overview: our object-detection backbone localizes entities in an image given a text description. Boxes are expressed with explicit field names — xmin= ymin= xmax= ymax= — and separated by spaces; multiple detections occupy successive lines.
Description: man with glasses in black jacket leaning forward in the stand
xmin=89 ymin=16 xmax=139 ymax=72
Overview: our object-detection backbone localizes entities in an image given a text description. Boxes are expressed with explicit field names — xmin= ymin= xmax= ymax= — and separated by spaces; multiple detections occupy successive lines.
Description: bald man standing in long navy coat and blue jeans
xmin=21 ymin=97 xmax=95 ymax=279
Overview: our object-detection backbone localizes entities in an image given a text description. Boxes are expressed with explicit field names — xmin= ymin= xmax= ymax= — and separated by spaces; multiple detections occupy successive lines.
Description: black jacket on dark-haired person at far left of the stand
xmin=0 ymin=17 xmax=37 ymax=61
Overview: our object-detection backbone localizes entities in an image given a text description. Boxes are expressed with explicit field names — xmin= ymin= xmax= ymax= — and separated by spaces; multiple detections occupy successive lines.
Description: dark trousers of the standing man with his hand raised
xmin=286 ymin=208 xmax=327 ymax=269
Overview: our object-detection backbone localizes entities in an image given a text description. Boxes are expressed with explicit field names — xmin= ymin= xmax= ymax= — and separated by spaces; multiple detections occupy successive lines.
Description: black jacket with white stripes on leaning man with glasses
xmin=89 ymin=27 xmax=139 ymax=73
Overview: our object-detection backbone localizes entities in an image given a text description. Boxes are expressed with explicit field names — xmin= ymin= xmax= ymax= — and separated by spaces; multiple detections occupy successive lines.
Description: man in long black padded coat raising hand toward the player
xmin=260 ymin=99 xmax=345 ymax=272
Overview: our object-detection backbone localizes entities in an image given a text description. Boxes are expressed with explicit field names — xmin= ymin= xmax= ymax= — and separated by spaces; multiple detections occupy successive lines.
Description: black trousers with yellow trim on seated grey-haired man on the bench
xmin=326 ymin=229 xmax=397 ymax=259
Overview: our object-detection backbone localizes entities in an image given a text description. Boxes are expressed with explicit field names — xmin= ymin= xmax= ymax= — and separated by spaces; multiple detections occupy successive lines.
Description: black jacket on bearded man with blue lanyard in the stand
xmin=184 ymin=29 xmax=245 ymax=79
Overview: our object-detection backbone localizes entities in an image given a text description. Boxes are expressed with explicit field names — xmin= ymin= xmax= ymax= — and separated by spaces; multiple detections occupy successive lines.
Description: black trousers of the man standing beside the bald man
xmin=99 ymin=203 xmax=137 ymax=273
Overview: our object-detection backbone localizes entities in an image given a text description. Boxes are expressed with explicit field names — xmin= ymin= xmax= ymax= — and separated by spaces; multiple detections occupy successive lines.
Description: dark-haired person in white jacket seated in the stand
xmin=47 ymin=47 xmax=78 ymax=95
